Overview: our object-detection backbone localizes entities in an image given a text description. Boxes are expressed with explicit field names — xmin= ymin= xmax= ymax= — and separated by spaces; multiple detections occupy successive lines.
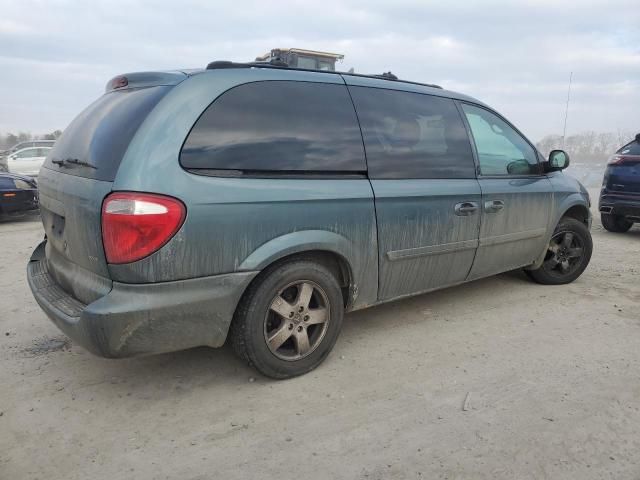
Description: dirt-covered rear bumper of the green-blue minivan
xmin=27 ymin=242 xmax=258 ymax=358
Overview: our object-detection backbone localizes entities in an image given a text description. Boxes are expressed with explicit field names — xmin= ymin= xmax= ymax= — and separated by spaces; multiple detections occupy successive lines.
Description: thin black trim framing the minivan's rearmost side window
xmin=178 ymin=77 xmax=369 ymax=180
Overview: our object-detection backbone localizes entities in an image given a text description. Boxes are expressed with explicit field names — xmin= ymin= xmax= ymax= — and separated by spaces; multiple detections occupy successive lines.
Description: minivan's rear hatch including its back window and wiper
xmin=38 ymin=75 xmax=180 ymax=303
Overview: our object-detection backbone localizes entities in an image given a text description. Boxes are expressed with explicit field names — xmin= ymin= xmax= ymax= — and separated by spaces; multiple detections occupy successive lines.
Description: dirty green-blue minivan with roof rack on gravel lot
xmin=28 ymin=62 xmax=592 ymax=378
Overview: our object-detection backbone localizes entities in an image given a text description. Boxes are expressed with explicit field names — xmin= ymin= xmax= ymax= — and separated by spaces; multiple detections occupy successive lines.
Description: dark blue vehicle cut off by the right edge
xmin=599 ymin=133 xmax=640 ymax=233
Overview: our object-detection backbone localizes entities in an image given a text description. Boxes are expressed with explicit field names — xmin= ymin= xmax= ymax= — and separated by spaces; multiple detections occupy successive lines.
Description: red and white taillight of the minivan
xmin=102 ymin=192 xmax=186 ymax=263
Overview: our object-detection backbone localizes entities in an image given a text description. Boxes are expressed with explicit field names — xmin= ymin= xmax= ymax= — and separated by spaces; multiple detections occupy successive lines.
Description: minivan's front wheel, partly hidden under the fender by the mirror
xmin=525 ymin=217 xmax=593 ymax=285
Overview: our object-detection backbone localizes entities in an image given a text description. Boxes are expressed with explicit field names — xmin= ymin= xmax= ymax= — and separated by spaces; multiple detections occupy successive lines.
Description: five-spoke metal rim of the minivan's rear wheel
xmin=264 ymin=280 xmax=331 ymax=361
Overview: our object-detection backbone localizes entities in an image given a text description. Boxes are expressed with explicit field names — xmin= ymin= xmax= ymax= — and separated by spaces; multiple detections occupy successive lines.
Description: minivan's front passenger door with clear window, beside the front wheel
xmin=461 ymin=103 xmax=553 ymax=280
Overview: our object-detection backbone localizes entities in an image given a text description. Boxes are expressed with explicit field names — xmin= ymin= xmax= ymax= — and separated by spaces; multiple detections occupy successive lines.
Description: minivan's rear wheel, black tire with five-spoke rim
xmin=229 ymin=259 xmax=344 ymax=379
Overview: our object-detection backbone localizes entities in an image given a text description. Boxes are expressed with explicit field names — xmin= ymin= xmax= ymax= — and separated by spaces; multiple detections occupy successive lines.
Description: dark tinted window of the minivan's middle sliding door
xmin=349 ymin=87 xmax=475 ymax=178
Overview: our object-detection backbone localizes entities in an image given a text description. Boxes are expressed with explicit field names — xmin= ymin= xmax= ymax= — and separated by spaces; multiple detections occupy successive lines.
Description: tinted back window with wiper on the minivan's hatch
xmin=45 ymin=86 xmax=171 ymax=181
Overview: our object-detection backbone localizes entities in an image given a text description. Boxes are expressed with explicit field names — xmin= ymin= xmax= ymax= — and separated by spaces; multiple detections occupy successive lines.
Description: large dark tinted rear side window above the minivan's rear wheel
xmin=180 ymin=81 xmax=366 ymax=173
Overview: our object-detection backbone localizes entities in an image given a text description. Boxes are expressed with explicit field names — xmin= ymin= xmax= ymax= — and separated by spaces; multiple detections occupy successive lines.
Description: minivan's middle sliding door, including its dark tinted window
xmin=347 ymin=80 xmax=480 ymax=300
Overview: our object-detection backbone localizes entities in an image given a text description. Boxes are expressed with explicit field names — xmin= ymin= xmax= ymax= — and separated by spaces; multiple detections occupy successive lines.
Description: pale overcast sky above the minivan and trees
xmin=0 ymin=0 xmax=640 ymax=141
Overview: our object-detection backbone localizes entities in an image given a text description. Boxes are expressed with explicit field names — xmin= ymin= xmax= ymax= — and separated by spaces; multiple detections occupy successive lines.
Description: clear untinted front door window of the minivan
xmin=462 ymin=104 xmax=540 ymax=175
